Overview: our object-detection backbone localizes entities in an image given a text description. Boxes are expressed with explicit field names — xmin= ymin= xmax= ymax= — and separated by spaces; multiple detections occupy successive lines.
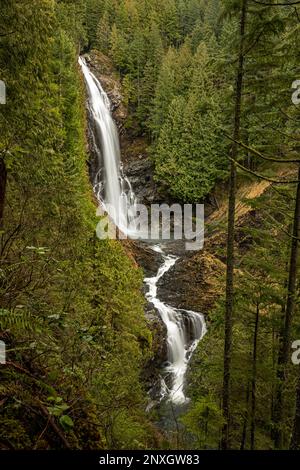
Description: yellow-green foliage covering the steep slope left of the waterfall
xmin=0 ymin=0 xmax=155 ymax=449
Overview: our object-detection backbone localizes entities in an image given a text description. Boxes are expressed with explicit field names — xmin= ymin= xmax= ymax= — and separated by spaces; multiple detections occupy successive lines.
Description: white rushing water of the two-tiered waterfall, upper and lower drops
xmin=79 ymin=58 xmax=206 ymax=404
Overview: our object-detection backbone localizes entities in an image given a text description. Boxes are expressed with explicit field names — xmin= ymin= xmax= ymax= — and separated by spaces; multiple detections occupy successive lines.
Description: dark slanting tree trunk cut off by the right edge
xmin=274 ymin=166 xmax=300 ymax=449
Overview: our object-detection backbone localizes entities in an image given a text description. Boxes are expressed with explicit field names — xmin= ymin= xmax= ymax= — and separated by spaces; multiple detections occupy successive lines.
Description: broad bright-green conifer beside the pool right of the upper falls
xmin=155 ymin=41 xmax=225 ymax=202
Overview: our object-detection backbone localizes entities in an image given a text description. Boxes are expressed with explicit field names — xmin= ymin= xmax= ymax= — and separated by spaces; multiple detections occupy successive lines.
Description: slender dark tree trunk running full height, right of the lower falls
xmin=221 ymin=0 xmax=248 ymax=450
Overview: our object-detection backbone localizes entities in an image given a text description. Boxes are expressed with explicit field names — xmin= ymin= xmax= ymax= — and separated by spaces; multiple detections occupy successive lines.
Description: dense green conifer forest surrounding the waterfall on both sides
xmin=0 ymin=0 xmax=300 ymax=450
